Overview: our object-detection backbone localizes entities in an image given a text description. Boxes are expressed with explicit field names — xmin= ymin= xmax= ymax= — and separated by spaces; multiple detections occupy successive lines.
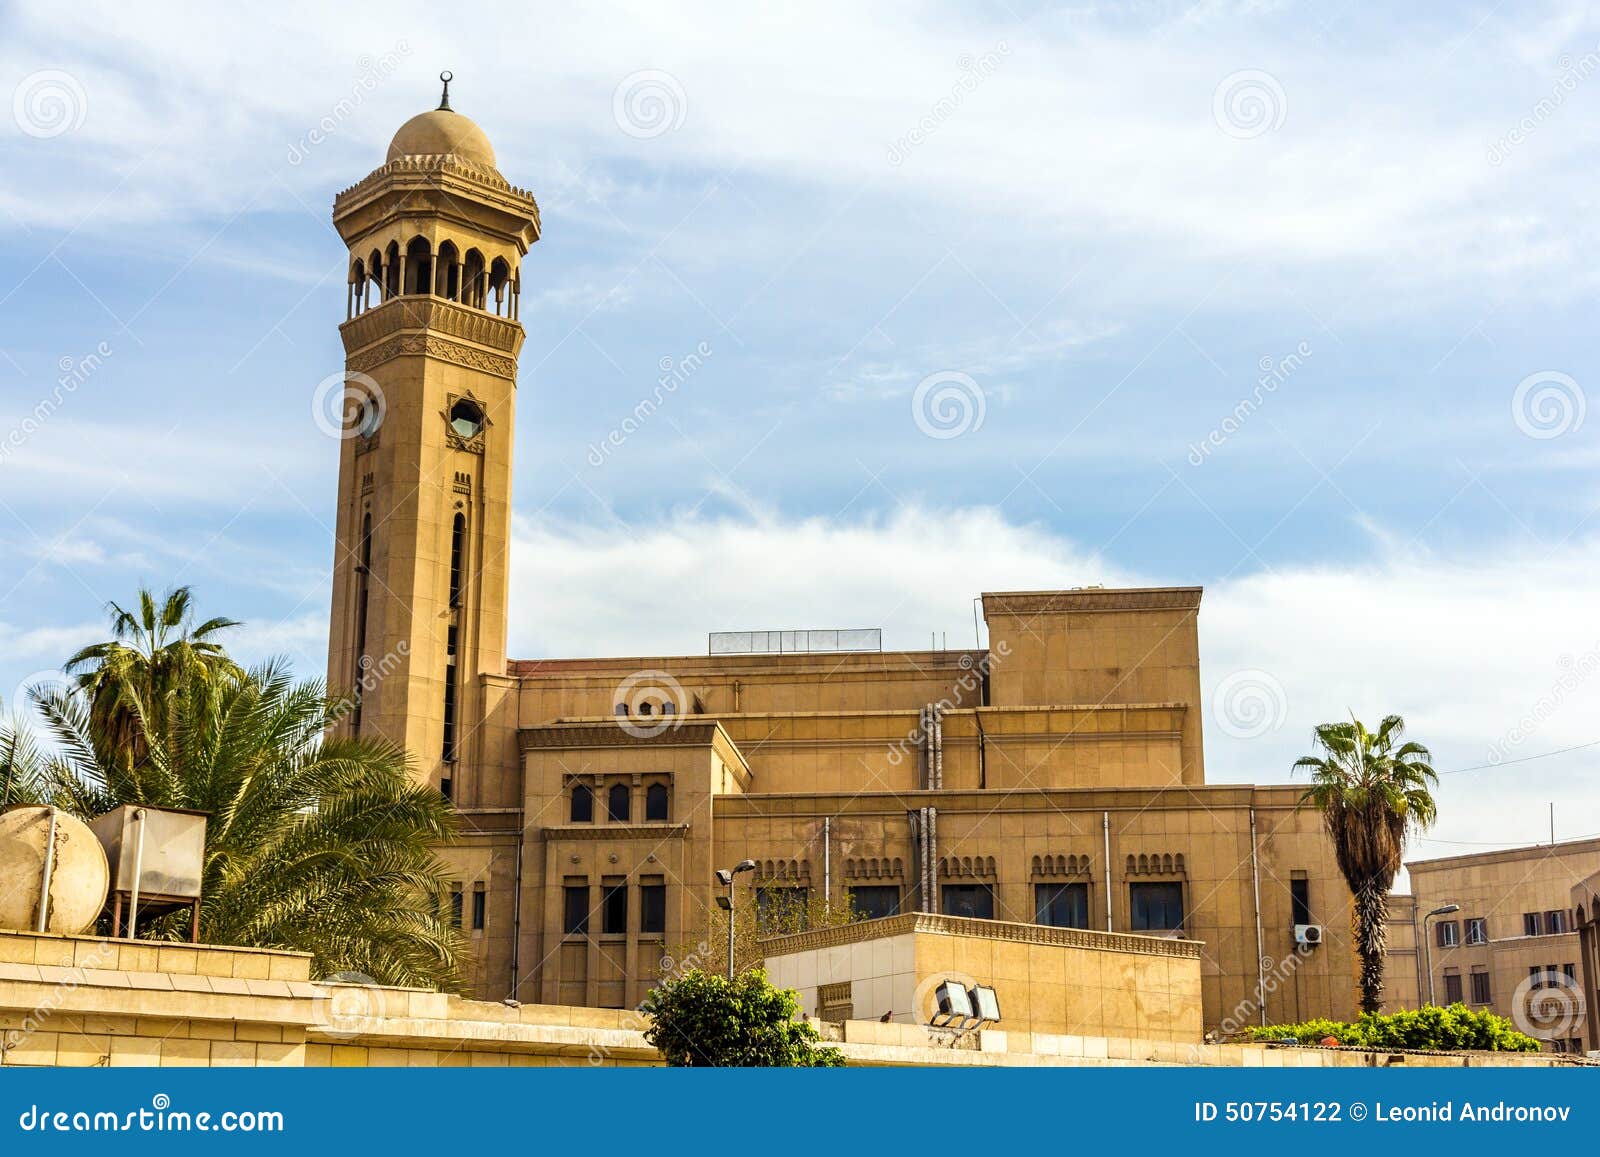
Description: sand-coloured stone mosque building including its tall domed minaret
xmin=328 ymin=88 xmax=1355 ymax=1027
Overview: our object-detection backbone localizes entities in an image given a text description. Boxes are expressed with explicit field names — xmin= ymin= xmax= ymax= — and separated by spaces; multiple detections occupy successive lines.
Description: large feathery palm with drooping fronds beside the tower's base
xmin=23 ymin=665 xmax=461 ymax=987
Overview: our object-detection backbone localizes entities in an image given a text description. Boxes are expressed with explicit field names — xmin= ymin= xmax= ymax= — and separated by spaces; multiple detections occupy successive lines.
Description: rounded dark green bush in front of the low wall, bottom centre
xmin=640 ymin=968 xmax=845 ymax=1069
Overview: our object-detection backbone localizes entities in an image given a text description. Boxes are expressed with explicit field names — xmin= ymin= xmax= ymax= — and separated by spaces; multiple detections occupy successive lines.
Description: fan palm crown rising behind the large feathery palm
xmin=64 ymin=587 xmax=240 ymax=799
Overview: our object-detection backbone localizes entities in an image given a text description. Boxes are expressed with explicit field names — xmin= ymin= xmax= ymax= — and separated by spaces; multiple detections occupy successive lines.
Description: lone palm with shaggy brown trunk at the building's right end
xmin=1294 ymin=715 xmax=1438 ymax=1013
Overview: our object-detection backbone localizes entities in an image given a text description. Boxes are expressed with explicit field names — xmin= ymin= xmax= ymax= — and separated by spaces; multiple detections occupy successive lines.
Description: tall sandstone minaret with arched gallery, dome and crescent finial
xmin=328 ymin=72 xmax=539 ymax=799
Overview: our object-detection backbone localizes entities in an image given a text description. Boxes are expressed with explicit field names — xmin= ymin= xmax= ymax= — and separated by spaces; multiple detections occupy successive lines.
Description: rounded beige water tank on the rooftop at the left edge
xmin=0 ymin=803 xmax=110 ymax=936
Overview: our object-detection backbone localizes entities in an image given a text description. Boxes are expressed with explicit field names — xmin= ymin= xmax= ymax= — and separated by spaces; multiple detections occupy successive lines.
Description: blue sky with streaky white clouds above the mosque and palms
xmin=0 ymin=3 xmax=1600 ymax=855
